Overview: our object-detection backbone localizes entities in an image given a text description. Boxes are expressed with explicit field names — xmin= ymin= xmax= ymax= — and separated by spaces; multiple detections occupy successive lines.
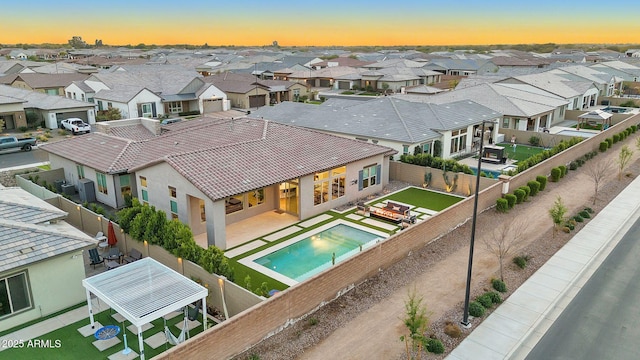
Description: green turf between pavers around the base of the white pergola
xmin=0 ymin=310 xmax=208 ymax=360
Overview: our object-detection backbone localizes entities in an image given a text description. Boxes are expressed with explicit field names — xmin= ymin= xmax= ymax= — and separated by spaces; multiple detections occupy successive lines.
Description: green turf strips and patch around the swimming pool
xmin=228 ymin=187 xmax=463 ymax=290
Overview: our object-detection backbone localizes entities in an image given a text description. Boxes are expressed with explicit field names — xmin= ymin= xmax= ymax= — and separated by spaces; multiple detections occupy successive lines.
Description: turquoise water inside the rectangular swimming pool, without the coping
xmin=253 ymin=224 xmax=380 ymax=281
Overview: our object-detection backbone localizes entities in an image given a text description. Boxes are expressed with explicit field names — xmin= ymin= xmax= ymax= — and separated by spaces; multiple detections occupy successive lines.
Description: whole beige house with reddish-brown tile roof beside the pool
xmin=41 ymin=116 xmax=395 ymax=250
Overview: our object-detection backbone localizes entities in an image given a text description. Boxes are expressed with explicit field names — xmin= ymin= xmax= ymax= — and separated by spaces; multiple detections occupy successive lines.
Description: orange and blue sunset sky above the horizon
xmin=0 ymin=0 xmax=640 ymax=46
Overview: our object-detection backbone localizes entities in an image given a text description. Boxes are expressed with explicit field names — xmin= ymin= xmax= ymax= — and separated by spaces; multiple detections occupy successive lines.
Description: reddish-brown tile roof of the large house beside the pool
xmin=41 ymin=118 xmax=395 ymax=200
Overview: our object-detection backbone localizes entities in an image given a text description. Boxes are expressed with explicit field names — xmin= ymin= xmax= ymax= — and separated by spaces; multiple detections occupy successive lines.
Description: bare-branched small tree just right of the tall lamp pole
xmin=483 ymin=219 xmax=528 ymax=280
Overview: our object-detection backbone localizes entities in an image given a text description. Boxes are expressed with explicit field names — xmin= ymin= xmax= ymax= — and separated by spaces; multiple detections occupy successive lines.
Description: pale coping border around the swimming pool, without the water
xmin=238 ymin=219 xmax=390 ymax=286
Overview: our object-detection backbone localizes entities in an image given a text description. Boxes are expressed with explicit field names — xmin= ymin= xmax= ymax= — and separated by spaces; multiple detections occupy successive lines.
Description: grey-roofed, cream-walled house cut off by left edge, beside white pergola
xmin=0 ymin=186 xmax=97 ymax=331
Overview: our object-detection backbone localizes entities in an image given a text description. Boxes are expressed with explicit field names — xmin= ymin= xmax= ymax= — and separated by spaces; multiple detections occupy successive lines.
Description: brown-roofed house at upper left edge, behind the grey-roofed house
xmin=0 ymin=73 xmax=88 ymax=96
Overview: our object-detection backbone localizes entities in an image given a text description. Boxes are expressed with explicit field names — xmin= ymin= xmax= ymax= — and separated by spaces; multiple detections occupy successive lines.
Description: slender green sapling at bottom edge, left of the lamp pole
xmin=400 ymin=287 xmax=429 ymax=359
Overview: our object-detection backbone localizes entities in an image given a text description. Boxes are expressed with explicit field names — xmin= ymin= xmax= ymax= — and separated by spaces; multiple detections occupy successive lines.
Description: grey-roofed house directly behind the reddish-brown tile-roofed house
xmin=252 ymin=96 xmax=501 ymax=158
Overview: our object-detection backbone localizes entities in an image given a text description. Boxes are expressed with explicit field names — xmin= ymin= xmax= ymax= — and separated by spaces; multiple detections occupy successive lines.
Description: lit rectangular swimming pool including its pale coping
xmin=239 ymin=220 xmax=389 ymax=286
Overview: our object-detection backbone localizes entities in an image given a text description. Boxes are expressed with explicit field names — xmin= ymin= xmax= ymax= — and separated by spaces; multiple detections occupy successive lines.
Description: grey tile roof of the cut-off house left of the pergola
xmin=0 ymin=187 xmax=97 ymax=273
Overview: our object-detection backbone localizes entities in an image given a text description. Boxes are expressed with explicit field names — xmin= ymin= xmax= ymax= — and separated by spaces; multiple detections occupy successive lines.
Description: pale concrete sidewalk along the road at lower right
xmin=447 ymin=178 xmax=640 ymax=360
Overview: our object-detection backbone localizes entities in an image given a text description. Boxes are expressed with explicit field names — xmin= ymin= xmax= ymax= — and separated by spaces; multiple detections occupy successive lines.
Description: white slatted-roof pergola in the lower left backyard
xmin=82 ymin=257 xmax=208 ymax=360
